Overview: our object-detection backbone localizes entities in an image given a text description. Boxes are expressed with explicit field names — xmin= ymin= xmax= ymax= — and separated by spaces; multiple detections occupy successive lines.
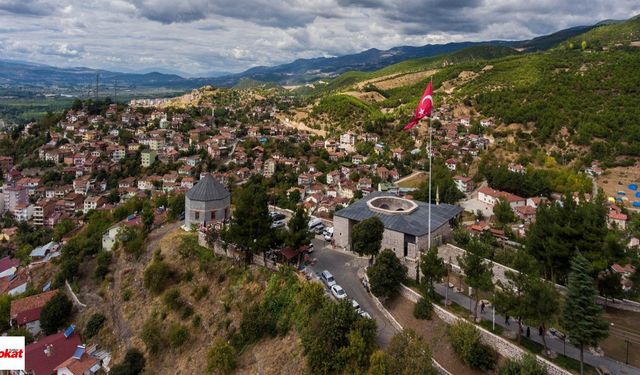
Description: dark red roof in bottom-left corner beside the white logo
xmin=24 ymin=332 xmax=81 ymax=375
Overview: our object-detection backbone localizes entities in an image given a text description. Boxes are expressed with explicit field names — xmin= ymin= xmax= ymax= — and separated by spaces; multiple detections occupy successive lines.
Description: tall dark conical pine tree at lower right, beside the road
xmin=560 ymin=253 xmax=608 ymax=374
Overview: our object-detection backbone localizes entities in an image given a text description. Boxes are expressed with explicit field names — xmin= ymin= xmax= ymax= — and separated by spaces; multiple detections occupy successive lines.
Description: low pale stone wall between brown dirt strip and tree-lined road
xmin=400 ymin=285 xmax=571 ymax=375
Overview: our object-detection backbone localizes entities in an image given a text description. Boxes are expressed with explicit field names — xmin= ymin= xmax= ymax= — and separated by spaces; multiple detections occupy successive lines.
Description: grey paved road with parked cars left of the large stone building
xmin=310 ymin=236 xmax=396 ymax=347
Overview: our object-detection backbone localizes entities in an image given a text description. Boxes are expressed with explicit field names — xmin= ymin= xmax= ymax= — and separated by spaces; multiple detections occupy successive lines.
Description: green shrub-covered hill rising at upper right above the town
xmin=304 ymin=16 xmax=640 ymax=163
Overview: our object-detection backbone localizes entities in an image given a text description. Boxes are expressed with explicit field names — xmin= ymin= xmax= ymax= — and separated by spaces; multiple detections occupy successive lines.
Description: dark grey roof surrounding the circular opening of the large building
xmin=334 ymin=191 xmax=462 ymax=236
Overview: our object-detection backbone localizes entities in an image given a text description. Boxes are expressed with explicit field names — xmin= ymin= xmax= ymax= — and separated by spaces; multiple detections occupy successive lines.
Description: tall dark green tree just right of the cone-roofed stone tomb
xmin=223 ymin=177 xmax=274 ymax=264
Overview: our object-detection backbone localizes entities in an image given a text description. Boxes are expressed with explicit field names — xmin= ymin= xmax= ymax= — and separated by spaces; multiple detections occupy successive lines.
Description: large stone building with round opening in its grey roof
xmin=333 ymin=192 xmax=462 ymax=268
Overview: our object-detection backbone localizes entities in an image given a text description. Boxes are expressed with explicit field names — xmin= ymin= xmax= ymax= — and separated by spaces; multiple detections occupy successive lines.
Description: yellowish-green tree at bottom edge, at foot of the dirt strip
xmin=385 ymin=329 xmax=437 ymax=375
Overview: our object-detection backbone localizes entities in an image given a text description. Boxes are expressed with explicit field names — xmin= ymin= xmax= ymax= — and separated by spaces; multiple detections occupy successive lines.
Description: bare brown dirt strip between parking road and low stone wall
xmin=386 ymin=296 xmax=483 ymax=375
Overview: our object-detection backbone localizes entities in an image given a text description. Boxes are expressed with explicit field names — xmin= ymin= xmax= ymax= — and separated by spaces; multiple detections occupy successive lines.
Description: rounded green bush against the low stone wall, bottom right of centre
xmin=447 ymin=321 xmax=496 ymax=371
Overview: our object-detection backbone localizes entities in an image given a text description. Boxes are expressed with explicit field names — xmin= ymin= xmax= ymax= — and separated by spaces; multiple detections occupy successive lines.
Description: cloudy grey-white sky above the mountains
xmin=0 ymin=0 xmax=640 ymax=75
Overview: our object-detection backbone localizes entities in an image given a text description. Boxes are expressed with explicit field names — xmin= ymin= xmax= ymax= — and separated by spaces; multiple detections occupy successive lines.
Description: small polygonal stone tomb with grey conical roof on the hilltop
xmin=184 ymin=174 xmax=231 ymax=227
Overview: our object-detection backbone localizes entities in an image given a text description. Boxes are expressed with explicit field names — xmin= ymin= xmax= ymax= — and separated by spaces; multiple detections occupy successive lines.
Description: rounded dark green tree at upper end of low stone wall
xmin=367 ymin=249 xmax=407 ymax=298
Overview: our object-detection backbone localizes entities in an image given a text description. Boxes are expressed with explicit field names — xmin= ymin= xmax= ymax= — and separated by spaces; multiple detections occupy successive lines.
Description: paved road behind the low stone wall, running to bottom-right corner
xmin=436 ymin=283 xmax=640 ymax=375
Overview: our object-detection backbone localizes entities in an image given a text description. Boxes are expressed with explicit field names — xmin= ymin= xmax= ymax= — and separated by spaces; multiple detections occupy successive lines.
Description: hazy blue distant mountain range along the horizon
xmin=0 ymin=21 xmax=612 ymax=90
